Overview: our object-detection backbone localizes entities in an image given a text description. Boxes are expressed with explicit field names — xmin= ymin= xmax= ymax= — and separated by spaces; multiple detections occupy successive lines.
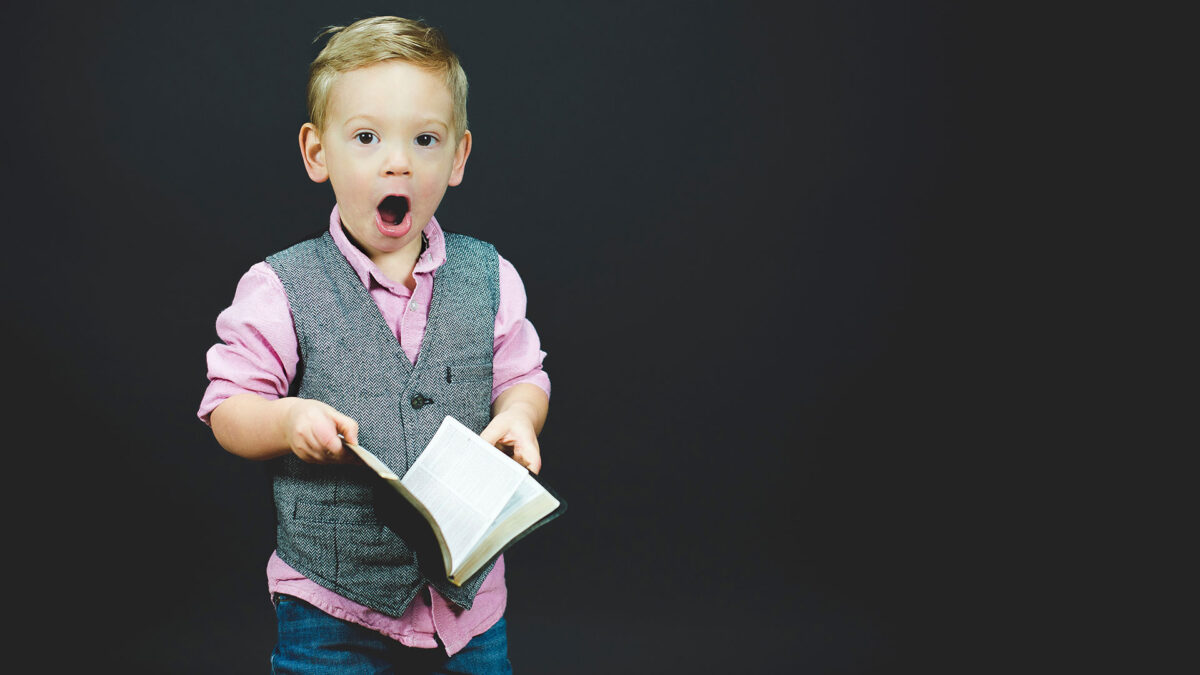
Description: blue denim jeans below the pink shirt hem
xmin=271 ymin=595 xmax=512 ymax=675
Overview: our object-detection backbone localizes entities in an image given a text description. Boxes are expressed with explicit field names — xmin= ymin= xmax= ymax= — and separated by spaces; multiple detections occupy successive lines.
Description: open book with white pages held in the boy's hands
xmin=347 ymin=416 xmax=565 ymax=586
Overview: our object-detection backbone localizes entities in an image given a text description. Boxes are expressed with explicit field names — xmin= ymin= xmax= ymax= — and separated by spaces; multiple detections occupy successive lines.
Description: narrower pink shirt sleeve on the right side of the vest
xmin=492 ymin=256 xmax=550 ymax=402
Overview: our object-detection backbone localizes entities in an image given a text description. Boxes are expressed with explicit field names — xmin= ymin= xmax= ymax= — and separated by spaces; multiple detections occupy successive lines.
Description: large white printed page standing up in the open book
xmin=401 ymin=417 xmax=528 ymax=566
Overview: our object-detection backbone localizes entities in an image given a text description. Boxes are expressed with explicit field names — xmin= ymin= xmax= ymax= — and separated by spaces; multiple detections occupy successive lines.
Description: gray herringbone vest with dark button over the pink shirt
xmin=266 ymin=232 xmax=499 ymax=616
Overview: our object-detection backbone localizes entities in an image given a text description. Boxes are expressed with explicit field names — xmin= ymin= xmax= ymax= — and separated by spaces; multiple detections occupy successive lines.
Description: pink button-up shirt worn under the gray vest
xmin=197 ymin=207 xmax=550 ymax=655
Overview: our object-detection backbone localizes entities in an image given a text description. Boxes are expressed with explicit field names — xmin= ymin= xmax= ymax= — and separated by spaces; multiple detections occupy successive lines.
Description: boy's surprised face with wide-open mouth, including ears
xmin=300 ymin=61 xmax=470 ymax=263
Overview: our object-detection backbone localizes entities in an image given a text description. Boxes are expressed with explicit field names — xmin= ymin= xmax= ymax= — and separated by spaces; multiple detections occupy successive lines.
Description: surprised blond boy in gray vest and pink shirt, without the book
xmin=198 ymin=17 xmax=550 ymax=673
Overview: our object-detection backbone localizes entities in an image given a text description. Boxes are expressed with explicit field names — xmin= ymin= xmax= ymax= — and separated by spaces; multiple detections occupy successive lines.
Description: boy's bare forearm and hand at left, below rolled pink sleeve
xmin=210 ymin=394 xmax=359 ymax=464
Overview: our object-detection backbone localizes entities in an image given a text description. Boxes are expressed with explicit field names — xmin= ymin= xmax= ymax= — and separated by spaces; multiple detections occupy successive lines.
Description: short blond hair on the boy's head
xmin=308 ymin=17 xmax=467 ymax=141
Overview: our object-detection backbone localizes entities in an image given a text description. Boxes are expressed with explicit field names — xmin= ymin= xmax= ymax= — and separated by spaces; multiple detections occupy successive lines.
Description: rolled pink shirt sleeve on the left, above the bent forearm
xmin=197 ymin=262 xmax=300 ymax=424
